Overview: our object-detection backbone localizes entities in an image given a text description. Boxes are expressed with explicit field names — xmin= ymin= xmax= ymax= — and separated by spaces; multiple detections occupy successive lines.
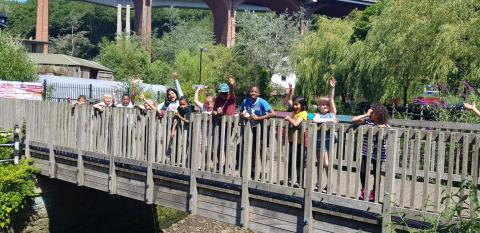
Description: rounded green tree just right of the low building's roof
xmin=97 ymin=37 xmax=149 ymax=81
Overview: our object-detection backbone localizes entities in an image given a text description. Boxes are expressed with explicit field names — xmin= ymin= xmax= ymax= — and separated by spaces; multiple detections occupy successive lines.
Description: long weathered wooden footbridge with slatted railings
xmin=0 ymin=99 xmax=480 ymax=232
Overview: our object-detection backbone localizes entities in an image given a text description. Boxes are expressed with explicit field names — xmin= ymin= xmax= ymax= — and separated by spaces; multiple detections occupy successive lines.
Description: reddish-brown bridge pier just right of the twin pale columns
xmin=133 ymin=0 xmax=152 ymax=54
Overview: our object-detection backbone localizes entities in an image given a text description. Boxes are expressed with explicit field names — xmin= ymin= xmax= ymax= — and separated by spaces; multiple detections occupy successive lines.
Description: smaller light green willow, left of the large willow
xmin=292 ymin=18 xmax=354 ymax=101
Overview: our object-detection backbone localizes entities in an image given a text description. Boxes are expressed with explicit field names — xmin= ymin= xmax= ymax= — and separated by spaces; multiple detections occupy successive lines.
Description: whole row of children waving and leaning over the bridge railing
xmin=68 ymin=73 xmax=389 ymax=201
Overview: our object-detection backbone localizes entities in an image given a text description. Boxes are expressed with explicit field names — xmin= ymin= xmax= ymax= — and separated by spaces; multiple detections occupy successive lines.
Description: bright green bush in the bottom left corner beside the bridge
xmin=0 ymin=160 xmax=35 ymax=230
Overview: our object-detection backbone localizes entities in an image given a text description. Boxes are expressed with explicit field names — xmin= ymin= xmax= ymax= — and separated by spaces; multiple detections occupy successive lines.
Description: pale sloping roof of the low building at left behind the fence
xmin=28 ymin=53 xmax=113 ymax=72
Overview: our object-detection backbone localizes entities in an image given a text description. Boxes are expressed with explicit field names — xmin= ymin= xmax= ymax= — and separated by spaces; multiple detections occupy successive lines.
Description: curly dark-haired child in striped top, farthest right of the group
xmin=352 ymin=104 xmax=389 ymax=201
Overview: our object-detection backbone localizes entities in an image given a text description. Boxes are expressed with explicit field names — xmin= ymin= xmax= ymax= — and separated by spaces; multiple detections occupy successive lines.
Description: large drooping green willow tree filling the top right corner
xmin=355 ymin=0 xmax=480 ymax=103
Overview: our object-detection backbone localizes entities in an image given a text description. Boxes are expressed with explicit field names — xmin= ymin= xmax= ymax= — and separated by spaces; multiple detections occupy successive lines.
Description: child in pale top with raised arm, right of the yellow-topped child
xmin=312 ymin=78 xmax=337 ymax=191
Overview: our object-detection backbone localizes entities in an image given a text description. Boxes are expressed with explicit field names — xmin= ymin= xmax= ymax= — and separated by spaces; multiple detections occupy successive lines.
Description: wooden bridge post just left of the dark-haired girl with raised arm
xmin=145 ymin=111 xmax=157 ymax=204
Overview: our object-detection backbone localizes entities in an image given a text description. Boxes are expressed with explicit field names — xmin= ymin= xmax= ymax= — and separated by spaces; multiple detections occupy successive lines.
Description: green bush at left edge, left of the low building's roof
xmin=0 ymin=31 xmax=35 ymax=82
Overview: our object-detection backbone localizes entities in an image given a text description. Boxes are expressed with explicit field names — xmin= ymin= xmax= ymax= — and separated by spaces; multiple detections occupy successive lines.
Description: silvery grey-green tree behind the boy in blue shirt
xmin=235 ymin=12 xmax=302 ymax=77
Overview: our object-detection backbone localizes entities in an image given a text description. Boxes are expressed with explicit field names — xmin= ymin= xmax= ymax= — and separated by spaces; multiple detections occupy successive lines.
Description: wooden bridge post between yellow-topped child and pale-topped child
xmin=303 ymin=124 xmax=316 ymax=232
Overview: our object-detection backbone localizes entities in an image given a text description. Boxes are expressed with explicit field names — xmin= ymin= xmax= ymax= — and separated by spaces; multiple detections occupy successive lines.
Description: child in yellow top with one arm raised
xmin=285 ymin=84 xmax=308 ymax=188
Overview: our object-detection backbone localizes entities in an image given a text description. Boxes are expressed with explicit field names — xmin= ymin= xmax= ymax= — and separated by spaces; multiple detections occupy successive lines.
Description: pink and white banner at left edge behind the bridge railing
xmin=0 ymin=81 xmax=43 ymax=100
